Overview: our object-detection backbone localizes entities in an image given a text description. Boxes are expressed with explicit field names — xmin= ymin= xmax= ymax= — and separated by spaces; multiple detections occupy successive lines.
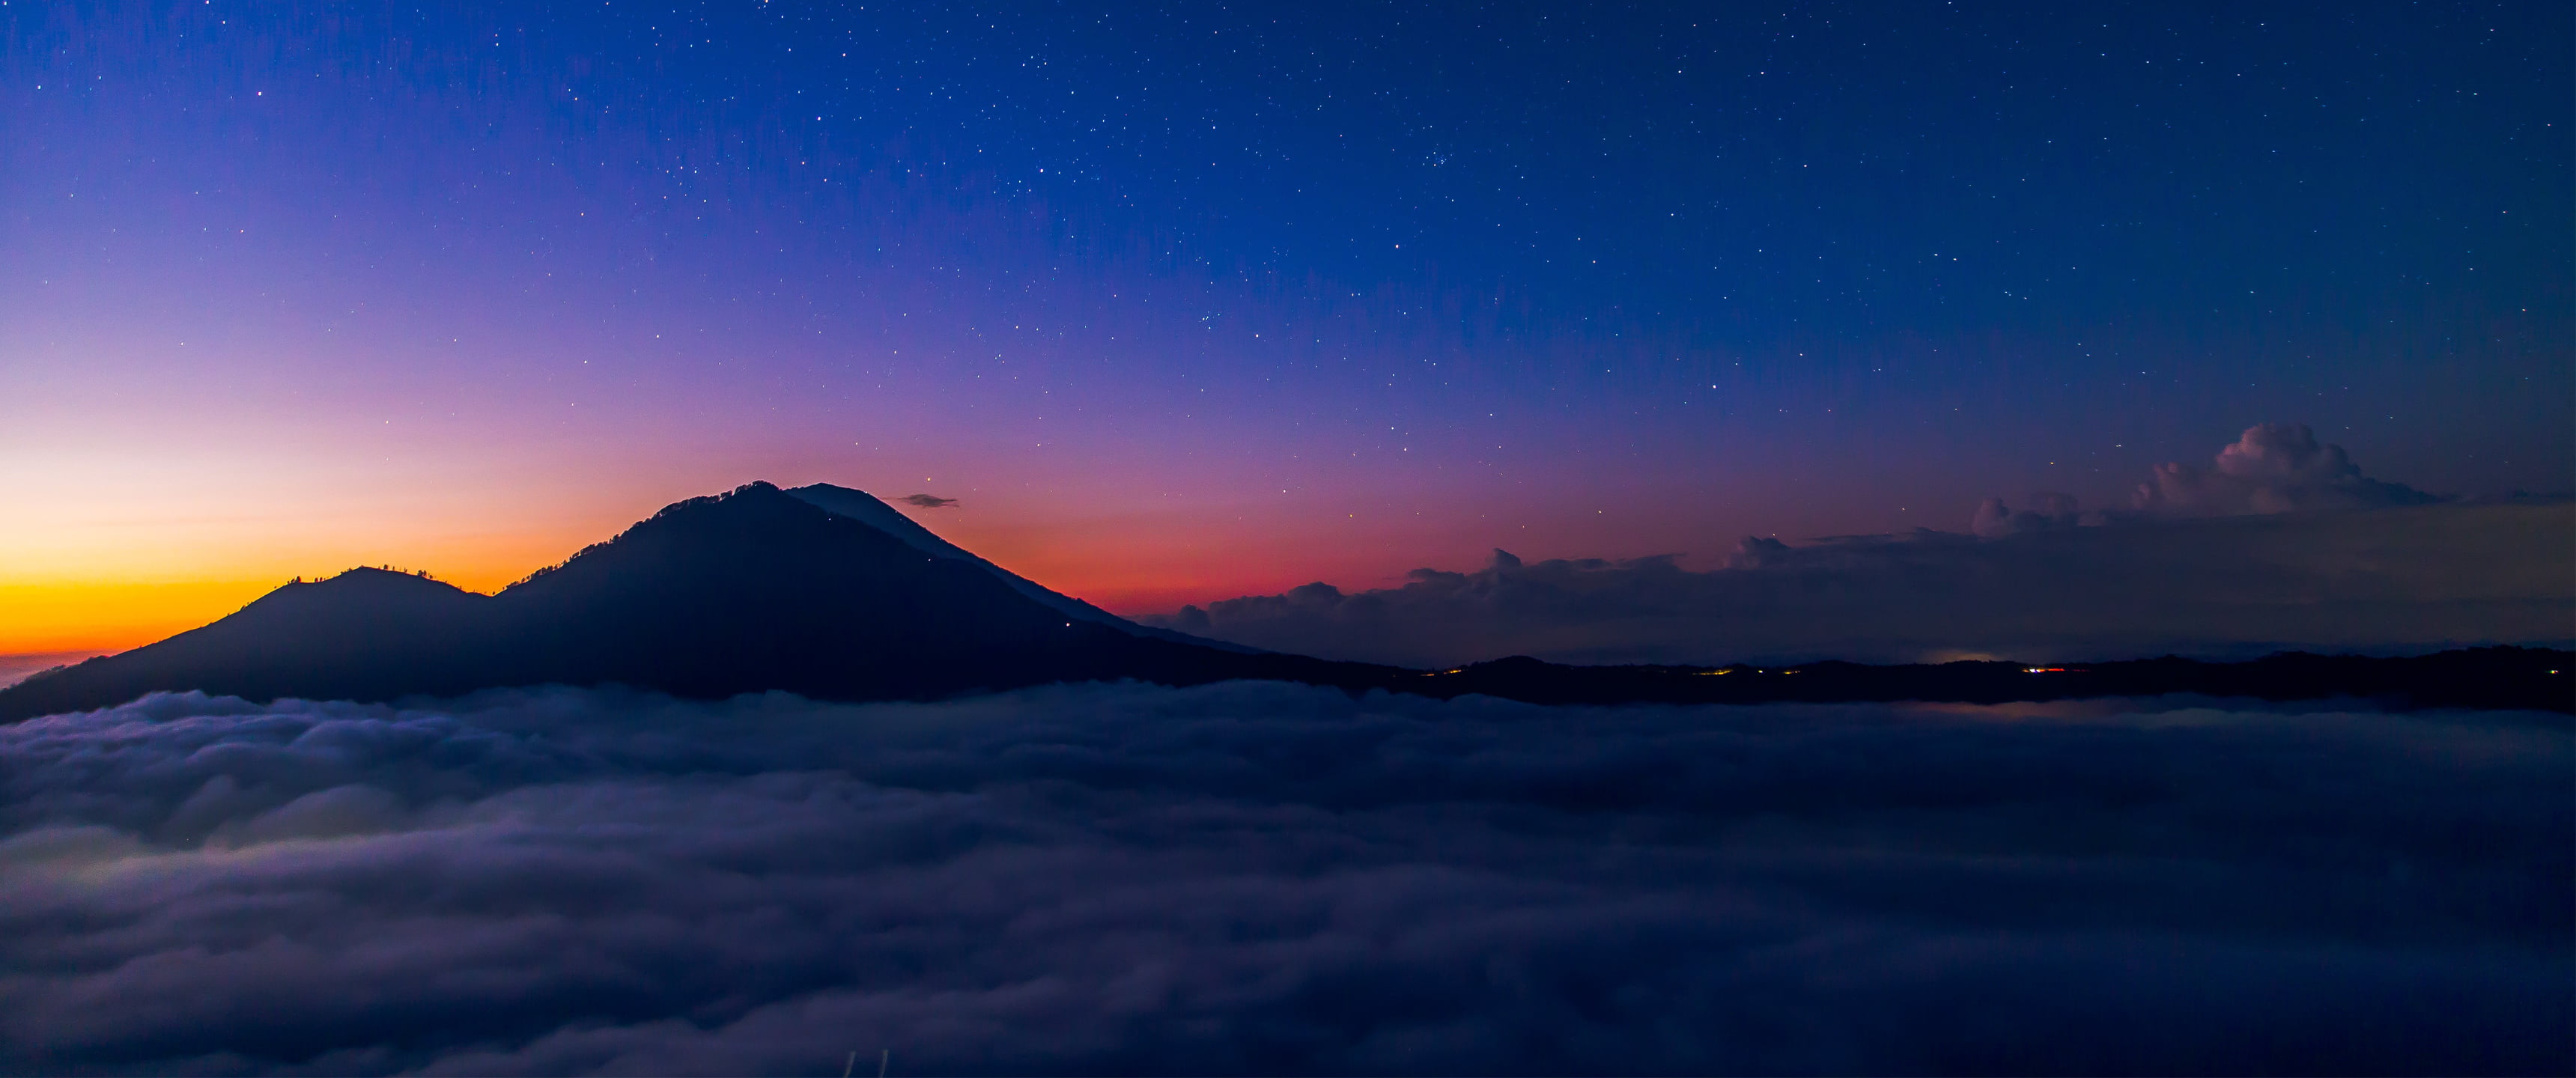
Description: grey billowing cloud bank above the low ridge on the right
xmin=1143 ymin=424 xmax=2576 ymax=666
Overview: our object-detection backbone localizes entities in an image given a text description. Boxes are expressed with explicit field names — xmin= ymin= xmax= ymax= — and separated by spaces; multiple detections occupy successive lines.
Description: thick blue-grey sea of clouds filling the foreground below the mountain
xmin=0 ymin=682 xmax=2576 ymax=1076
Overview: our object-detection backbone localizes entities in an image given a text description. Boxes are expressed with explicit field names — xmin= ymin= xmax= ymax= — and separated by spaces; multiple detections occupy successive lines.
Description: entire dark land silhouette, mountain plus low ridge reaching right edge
xmin=0 ymin=484 xmax=2576 ymax=720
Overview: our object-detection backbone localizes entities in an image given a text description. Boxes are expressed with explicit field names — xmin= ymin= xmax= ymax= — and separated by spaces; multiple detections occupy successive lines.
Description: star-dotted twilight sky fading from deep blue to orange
xmin=0 ymin=0 xmax=2576 ymax=651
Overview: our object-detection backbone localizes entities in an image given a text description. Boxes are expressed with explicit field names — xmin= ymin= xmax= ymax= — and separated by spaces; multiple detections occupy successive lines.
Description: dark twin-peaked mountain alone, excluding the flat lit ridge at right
xmin=0 ymin=484 xmax=1394 ymax=720
